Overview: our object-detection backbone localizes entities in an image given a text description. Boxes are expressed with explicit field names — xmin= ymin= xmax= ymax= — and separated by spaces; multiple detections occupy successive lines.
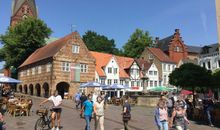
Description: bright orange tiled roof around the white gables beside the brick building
xmin=90 ymin=51 xmax=134 ymax=78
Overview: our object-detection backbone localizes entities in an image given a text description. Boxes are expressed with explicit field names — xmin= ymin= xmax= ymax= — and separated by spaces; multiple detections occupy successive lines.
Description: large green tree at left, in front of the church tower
xmin=0 ymin=18 xmax=52 ymax=68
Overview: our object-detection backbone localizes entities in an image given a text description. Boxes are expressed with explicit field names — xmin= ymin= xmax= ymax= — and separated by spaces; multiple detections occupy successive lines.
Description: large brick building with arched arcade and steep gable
xmin=17 ymin=32 xmax=95 ymax=97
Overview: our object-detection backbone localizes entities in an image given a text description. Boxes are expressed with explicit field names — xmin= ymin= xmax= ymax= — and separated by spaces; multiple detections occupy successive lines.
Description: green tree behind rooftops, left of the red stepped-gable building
xmin=123 ymin=29 xmax=152 ymax=58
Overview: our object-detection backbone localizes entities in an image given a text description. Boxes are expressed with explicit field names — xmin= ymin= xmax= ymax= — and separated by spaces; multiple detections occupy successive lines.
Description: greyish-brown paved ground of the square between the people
xmin=5 ymin=97 xmax=220 ymax=130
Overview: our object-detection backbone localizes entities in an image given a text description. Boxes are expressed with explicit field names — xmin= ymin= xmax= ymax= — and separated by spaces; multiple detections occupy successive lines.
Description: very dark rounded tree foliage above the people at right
xmin=169 ymin=63 xmax=211 ymax=87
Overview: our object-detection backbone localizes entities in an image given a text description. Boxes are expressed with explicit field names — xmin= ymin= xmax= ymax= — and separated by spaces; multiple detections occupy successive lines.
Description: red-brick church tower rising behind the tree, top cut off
xmin=10 ymin=0 xmax=38 ymax=26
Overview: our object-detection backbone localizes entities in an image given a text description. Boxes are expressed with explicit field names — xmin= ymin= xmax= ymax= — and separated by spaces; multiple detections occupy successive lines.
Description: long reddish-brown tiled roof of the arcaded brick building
xmin=19 ymin=32 xmax=78 ymax=68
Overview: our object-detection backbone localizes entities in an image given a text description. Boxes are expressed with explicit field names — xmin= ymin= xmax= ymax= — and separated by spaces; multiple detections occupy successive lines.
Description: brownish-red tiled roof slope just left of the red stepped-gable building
xmin=148 ymin=47 xmax=175 ymax=63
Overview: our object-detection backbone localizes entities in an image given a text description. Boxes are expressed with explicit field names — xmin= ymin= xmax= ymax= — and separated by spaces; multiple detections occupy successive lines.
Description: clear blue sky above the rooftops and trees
xmin=0 ymin=0 xmax=217 ymax=48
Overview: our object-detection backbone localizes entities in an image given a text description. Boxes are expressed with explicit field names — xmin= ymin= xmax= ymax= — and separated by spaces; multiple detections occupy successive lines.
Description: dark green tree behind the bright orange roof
xmin=82 ymin=31 xmax=121 ymax=55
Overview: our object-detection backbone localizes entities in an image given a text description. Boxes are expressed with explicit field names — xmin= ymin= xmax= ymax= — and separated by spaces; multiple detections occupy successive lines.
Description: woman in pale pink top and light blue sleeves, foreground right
xmin=154 ymin=99 xmax=168 ymax=130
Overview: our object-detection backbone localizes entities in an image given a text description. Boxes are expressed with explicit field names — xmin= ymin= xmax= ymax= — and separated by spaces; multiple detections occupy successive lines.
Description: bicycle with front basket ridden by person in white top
xmin=34 ymin=107 xmax=52 ymax=130
